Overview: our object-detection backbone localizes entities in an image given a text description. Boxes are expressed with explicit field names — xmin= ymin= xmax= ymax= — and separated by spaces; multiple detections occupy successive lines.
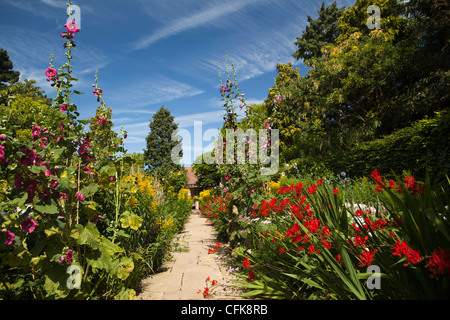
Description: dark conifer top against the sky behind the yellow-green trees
xmin=292 ymin=1 xmax=344 ymax=61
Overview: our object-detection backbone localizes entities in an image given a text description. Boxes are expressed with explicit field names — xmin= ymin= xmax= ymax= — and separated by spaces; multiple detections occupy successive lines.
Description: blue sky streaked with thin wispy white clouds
xmin=0 ymin=0 xmax=355 ymax=165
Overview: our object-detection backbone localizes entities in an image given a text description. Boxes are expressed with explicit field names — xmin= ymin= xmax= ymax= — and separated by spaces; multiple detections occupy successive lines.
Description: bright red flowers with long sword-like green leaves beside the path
xmin=201 ymin=174 xmax=450 ymax=299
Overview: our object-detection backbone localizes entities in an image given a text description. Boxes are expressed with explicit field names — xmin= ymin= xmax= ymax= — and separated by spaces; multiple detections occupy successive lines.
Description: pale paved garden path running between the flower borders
xmin=135 ymin=210 xmax=243 ymax=300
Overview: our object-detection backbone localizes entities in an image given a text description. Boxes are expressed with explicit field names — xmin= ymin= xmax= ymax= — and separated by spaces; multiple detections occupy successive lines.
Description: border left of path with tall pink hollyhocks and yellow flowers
xmin=0 ymin=3 xmax=190 ymax=299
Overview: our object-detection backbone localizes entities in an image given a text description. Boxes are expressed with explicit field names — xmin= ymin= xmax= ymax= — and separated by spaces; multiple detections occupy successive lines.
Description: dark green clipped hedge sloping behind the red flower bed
xmin=323 ymin=111 xmax=450 ymax=183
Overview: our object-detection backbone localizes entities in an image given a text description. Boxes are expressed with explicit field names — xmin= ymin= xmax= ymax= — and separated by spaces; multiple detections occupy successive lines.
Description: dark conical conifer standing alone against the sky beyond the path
xmin=144 ymin=106 xmax=183 ymax=176
